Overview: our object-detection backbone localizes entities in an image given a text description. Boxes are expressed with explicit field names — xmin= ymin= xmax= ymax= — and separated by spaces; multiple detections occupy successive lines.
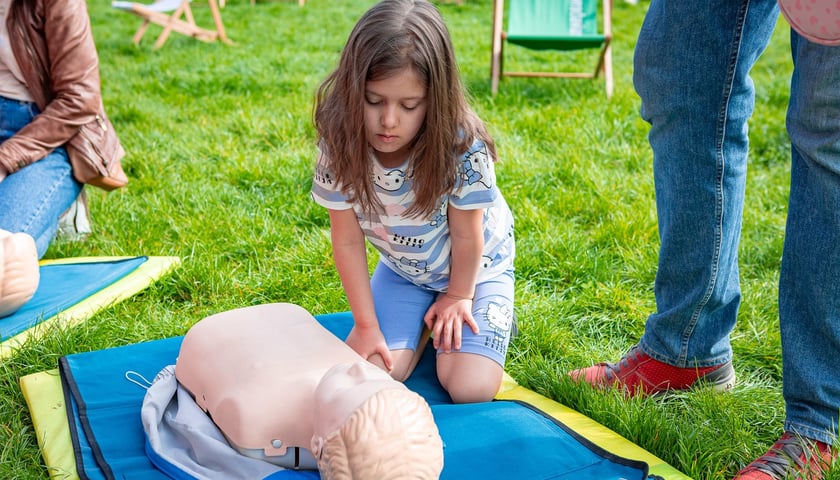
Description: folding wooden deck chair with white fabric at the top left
xmin=111 ymin=0 xmax=232 ymax=49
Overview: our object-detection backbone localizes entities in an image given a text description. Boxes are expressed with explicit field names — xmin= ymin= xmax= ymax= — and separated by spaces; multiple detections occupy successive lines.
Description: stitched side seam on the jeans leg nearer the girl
xmin=677 ymin=0 xmax=750 ymax=366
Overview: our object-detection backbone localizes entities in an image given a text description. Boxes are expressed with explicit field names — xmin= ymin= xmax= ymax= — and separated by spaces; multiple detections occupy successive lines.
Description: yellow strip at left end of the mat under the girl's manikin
xmin=20 ymin=369 xmax=79 ymax=480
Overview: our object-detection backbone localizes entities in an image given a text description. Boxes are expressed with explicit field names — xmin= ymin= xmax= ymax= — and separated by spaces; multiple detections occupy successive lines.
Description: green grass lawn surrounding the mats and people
xmin=0 ymin=0 xmax=838 ymax=480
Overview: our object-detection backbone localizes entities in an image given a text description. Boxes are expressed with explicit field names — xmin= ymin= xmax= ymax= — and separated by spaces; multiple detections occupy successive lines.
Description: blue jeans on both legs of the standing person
xmin=634 ymin=0 xmax=840 ymax=443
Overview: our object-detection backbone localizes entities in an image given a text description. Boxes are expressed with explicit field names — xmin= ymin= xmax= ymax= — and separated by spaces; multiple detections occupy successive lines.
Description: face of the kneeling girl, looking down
xmin=365 ymin=68 xmax=426 ymax=167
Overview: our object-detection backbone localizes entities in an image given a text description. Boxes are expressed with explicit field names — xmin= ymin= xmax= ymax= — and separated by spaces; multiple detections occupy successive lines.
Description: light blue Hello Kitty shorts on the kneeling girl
xmin=370 ymin=262 xmax=513 ymax=367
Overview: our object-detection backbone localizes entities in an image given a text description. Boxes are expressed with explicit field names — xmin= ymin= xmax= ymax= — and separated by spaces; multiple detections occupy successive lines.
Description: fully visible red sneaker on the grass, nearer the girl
xmin=569 ymin=346 xmax=735 ymax=396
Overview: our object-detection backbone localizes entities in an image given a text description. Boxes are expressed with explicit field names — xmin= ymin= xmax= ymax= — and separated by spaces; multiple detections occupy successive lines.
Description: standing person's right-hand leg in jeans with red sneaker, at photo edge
xmin=736 ymin=32 xmax=840 ymax=480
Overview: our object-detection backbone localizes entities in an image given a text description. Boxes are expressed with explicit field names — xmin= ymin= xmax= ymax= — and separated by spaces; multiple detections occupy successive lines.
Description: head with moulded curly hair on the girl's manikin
xmin=312 ymin=360 xmax=443 ymax=480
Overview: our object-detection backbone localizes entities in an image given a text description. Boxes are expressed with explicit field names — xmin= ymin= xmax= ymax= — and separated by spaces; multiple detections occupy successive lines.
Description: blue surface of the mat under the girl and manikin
xmin=59 ymin=313 xmax=648 ymax=480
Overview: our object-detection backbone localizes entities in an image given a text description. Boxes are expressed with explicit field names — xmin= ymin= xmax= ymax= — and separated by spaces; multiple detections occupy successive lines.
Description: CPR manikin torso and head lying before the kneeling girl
xmin=175 ymin=303 xmax=443 ymax=479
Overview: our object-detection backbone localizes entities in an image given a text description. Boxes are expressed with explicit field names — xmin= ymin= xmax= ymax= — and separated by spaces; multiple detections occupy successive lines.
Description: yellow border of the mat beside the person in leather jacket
xmin=0 ymin=256 xmax=181 ymax=360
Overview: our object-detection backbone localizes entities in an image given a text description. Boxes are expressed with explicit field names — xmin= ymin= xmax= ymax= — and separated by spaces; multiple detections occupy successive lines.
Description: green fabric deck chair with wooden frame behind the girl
xmin=490 ymin=0 xmax=613 ymax=97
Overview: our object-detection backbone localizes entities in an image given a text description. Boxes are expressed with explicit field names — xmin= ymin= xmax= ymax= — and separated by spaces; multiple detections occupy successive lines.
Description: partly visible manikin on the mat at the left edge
xmin=0 ymin=230 xmax=40 ymax=318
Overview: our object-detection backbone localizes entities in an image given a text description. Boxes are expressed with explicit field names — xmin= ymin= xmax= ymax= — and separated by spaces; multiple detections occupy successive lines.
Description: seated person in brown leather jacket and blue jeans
xmin=0 ymin=0 xmax=127 ymax=258
